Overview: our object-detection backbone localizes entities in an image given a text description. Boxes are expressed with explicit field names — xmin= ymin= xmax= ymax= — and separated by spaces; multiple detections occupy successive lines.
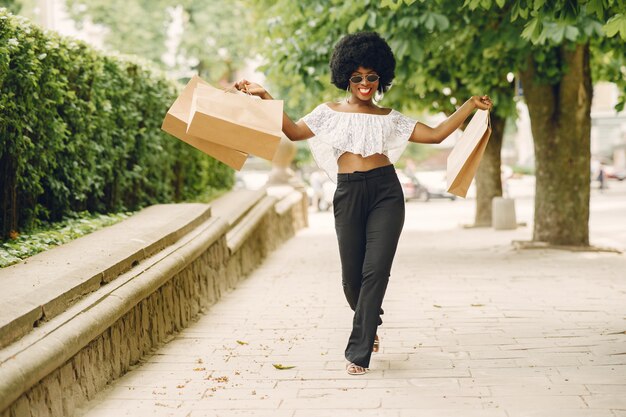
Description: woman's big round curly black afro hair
xmin=330 ymin=32 xmax=396 ymax=92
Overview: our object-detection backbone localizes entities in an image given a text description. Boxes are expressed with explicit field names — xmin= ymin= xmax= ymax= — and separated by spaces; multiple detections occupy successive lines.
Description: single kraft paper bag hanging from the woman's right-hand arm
xmin=446 ymin=110 xmax=491 ymax=197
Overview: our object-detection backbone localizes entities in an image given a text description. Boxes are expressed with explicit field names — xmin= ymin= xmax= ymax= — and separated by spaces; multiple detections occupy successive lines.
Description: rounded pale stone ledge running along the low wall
xmin=0 ymin=190 xmax=303 ymax=416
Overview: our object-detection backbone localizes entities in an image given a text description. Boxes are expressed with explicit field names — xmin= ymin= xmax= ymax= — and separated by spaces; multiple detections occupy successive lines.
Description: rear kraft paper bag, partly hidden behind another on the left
xmin=161 ymin=76 xmax=248 ymax=170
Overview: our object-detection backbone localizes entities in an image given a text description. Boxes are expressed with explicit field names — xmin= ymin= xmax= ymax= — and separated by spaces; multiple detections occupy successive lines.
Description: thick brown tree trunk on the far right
xmin=521 ymin=44 xmax=592 ymax=246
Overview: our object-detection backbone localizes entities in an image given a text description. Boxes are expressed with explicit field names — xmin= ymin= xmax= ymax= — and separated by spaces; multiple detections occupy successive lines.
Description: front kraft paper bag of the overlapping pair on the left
xmin=187 ymin=84 xmax=283 ymax=161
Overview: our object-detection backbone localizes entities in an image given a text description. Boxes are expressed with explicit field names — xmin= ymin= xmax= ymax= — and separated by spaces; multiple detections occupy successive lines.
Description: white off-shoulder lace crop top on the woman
xmin=301 ymin=103 xmax=417 ymax=182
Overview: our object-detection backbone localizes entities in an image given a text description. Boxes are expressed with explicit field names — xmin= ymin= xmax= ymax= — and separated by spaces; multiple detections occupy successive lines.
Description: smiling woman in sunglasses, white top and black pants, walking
xmin=235 ymin=33 xmax=492 ymax=375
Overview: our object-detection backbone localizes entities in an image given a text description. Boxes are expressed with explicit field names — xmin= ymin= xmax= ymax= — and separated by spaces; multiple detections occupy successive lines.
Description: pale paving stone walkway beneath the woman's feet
xmin=78 ymin=194 xmax=626 ymax=417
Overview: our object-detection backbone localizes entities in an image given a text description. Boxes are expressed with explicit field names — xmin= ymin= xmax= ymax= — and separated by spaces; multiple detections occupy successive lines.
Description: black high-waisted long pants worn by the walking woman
xmin=333 ymin=165 xmax=404 ymax=368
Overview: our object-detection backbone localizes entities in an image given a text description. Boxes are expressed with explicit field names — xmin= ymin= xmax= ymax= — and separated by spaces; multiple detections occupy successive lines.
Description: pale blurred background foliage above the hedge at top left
xmin=67 ymin=0 xmax=252 ymax=82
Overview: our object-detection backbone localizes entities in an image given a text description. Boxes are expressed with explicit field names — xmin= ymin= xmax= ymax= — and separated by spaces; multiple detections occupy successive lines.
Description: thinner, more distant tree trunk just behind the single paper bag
xmin=474 ymin=113 xmax=506 ymax=227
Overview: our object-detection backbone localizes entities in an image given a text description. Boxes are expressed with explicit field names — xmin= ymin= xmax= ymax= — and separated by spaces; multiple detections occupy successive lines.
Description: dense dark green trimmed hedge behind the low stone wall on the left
xmin=0 ymin=9 xmax=234 ymax=238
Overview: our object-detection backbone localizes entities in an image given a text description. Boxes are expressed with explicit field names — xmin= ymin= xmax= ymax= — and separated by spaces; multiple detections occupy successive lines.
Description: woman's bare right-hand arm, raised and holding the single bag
xmin=409 ymin=96 xmax=493 ymax=143
